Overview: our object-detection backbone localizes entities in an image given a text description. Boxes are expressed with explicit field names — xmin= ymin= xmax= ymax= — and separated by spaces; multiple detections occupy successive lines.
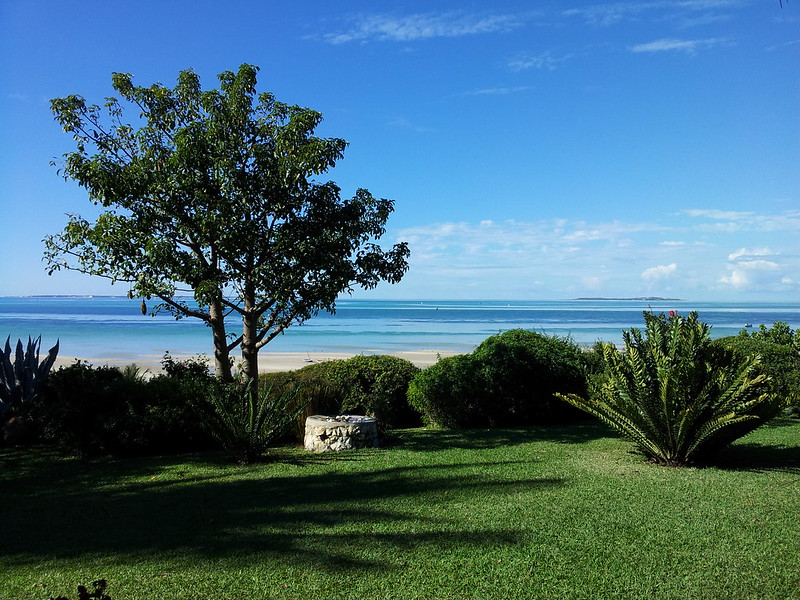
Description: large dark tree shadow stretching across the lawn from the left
xmin=0 ymin=454 xmax=563 ymax=571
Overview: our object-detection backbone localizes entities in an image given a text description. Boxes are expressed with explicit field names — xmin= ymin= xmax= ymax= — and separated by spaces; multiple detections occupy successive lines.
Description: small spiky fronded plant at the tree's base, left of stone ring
xmin=195 ymin=380 xmax=304 ymax=464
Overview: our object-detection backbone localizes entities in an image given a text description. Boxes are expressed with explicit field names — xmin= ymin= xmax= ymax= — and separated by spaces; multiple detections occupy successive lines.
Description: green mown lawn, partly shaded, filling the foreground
xmin=0 ymin=421 xmax=800 ymax=600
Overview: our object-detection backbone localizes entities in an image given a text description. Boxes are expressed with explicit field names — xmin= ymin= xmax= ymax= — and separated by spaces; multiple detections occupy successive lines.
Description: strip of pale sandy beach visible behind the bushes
xmin=54 ymin=350 xmax=456 ymax=373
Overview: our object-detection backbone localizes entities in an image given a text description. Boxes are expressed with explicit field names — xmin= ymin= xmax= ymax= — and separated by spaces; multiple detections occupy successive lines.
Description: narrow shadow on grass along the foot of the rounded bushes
xmin=390 ymin=421 xmax=620 ymax=452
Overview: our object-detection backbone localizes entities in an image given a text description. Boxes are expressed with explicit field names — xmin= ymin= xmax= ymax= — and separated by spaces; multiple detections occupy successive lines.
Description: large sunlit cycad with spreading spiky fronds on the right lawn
xmin=559 ymin=312 xmax=785 ymax=466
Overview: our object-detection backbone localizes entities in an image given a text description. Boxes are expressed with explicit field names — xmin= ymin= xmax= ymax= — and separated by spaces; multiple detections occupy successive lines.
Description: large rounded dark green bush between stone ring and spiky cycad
xmin=408 ymin=329 xmax=591 ymax=428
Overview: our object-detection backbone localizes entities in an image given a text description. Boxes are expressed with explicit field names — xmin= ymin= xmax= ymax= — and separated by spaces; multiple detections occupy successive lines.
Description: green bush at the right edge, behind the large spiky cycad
xmin=714 ymin=338 xmax=800 ymax=417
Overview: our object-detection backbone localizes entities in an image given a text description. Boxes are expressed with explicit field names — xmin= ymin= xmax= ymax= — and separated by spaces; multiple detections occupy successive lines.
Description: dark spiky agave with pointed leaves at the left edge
xmin=0 ymin=336 xmax=58 ymax=416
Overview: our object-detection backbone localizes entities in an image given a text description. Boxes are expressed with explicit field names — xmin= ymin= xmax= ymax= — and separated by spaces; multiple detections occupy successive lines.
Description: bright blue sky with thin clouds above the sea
xmin=0 ymin=0 xmax=800 ymax=302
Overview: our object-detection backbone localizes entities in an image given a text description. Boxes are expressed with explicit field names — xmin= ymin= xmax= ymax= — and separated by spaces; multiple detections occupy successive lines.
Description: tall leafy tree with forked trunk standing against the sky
xmin=45 ymin=64 xmax=409 ymax=380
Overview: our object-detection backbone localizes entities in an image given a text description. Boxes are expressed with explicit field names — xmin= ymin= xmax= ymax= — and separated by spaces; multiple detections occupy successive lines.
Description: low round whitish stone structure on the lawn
xmin=304 ymin=415 xmax=379 ymax=452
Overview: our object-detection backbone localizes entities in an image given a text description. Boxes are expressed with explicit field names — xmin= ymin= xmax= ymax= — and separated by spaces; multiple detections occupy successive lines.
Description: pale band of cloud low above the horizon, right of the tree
xmin=395 ymin=209 xmax=800 ymax=298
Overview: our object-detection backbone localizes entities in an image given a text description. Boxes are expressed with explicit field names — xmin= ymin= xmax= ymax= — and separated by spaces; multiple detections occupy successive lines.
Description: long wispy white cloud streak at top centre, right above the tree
xmin=323 ymin=11 xmax=523 ymax=44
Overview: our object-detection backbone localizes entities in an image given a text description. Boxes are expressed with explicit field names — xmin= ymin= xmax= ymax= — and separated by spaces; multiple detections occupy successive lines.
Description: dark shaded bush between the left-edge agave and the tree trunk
xmin=28 ymin=362 xmax=216 ymax=456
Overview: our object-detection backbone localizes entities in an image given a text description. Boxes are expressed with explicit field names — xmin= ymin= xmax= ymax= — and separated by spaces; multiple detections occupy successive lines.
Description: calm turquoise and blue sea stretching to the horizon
xmin=0 ymin=297 xmax=800 ymax=361
